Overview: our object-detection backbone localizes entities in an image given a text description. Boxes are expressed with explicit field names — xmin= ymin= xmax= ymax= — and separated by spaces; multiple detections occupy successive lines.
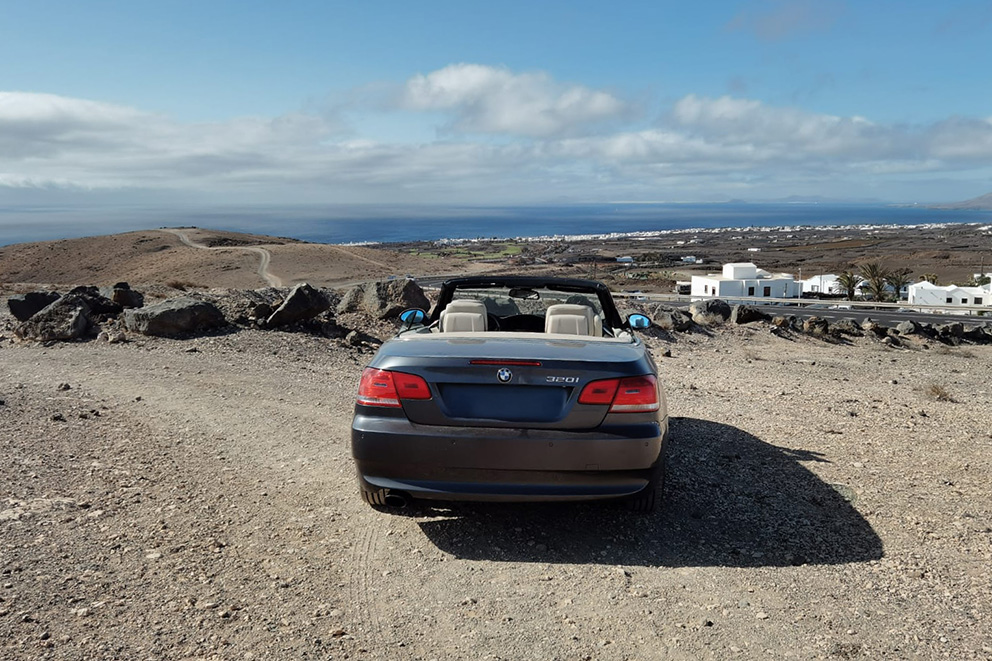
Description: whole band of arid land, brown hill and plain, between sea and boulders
xmin=0 ymin=224 xmax=992 ymax=292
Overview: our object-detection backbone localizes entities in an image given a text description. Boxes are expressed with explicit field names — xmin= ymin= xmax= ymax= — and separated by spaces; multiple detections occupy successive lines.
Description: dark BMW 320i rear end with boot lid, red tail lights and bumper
xmin=352 ymin=333 xmax=668 ymax=505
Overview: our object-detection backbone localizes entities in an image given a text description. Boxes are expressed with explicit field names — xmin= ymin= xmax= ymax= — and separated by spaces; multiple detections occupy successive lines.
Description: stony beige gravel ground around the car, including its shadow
xmin=0 ymin=319 xmax=992 ymax=660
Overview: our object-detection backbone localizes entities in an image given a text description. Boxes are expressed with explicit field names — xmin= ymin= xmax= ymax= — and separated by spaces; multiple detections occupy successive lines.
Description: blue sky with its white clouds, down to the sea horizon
xmin=0 ymin=0 xmax=992 ymax=205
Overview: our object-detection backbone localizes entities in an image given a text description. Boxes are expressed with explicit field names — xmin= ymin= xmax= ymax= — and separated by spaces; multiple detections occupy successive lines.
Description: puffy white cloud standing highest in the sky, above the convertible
xmin=401 ymin=64 xmax=627 ymax=136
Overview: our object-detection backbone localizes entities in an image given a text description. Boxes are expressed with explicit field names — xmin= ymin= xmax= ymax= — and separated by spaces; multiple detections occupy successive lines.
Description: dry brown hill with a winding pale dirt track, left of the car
xmin=0 ymin=228 xmax=462 ymax=288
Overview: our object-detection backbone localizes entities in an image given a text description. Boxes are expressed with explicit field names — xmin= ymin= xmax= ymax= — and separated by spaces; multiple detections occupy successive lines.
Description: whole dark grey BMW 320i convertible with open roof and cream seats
xmin=351 ymin=277 xmax=668 ymax=511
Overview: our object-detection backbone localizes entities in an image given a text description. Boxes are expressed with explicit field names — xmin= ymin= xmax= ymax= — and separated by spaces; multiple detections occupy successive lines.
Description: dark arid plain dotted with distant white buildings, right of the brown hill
xmin=380 ymin=224 xmax=992 ymax=293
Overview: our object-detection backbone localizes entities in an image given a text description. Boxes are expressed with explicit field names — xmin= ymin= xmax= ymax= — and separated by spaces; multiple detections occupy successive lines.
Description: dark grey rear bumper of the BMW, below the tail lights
xmin=351 ymin=415 xmax=668 ymax=501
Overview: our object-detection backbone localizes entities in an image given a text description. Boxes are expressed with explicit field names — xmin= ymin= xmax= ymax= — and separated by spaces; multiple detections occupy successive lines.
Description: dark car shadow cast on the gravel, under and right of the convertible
xmin=407 ymin=418 xmax=883 ymax=567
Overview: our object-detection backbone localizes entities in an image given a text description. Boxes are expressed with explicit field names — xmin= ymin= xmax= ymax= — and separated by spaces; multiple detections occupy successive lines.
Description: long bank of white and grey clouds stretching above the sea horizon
xmin=0 ymin=85 xmax=992 ymax=204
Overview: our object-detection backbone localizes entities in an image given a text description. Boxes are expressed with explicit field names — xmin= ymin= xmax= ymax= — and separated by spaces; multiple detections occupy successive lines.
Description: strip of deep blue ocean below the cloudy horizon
xmin=0 ymin=203 xmax=992 ymax=245
